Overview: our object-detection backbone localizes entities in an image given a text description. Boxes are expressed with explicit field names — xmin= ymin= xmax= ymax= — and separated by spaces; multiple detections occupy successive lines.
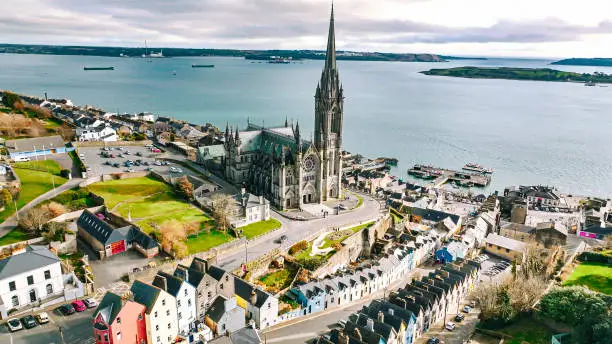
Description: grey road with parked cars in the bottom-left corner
xmin=0 ymin=309 xmax=94 ymax=344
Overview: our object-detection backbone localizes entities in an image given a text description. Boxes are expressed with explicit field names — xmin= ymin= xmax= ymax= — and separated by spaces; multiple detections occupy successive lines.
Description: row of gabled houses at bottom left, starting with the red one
xmin=93 ymin=258 xmax=278 ymax=344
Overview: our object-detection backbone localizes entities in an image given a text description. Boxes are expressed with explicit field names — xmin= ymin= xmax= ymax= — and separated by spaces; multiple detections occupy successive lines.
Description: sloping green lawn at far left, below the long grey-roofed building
xmin=0 ymin=168 xmax=66 ymax=223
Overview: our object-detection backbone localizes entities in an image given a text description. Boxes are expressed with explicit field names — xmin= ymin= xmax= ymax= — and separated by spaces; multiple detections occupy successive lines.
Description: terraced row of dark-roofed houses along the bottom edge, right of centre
xmin=318 ymin=258 xmax=480 ymax=344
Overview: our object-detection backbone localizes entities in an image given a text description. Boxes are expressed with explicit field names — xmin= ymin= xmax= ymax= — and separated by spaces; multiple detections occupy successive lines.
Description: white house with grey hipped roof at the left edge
xmin=0 ymin=246 xmax=64 ymax=319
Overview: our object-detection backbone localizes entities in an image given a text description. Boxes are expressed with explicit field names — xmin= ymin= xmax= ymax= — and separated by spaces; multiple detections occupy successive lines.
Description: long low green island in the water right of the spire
xmin=421 ymin=67 xmax=612 ymax=86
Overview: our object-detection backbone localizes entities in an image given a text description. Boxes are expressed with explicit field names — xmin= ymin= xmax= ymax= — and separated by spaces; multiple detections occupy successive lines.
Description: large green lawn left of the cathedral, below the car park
xmin=88 ymin=177 xmax=228 ymax=254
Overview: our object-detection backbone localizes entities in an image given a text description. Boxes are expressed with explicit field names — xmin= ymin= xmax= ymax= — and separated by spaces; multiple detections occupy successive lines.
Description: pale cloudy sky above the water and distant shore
xmin=0 ymin=0 xmax=612 ymax=58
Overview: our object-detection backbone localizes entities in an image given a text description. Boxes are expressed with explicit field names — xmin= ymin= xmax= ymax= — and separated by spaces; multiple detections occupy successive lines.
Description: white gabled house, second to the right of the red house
xmin=153 ymin=272 xmax=197 ymax=335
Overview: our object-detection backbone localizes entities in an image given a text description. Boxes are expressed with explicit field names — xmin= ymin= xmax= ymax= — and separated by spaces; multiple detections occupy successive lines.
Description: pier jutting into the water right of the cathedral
xmin=408 ymin=164 xmax=491 ymax=188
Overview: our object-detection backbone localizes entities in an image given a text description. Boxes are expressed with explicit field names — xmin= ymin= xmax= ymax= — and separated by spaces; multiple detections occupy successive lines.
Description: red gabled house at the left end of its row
xmin=93 ymin=293 xmax=147 ymax=344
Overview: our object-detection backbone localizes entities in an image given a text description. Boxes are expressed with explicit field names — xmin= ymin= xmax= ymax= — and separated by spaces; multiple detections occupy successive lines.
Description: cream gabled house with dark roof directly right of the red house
xmin=130 ymin=280 xmax=179 ymax=344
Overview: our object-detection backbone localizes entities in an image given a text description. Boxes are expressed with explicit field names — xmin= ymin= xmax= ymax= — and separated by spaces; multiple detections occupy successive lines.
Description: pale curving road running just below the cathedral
xmin=216 ymin=195 xmax=380 ymax=270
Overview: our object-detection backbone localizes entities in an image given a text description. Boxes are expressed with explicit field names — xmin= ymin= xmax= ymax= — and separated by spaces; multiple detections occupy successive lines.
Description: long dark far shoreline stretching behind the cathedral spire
xmin=0 ymin=44 xmax=456 ymax=62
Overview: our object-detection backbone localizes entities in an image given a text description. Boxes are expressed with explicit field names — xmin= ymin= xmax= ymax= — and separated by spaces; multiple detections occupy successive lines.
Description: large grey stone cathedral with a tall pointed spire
xmin=222 ymin=7 xmax=344 ymax=210
